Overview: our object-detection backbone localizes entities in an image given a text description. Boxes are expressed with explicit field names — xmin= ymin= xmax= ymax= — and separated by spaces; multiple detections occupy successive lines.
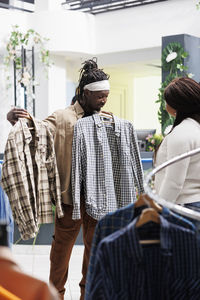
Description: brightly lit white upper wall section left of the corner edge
xmin=0 ymin=8 xmax=96 ymax=54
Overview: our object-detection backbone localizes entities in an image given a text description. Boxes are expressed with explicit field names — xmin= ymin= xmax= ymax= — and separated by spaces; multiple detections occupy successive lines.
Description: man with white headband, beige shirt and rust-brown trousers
xmin=7 ymin=58 xmax=110 ymax=300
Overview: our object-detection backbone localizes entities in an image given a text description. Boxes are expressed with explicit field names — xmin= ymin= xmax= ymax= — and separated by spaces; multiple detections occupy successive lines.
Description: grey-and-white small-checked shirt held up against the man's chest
xmin=72 ymin=114 xmax=143 ymax=220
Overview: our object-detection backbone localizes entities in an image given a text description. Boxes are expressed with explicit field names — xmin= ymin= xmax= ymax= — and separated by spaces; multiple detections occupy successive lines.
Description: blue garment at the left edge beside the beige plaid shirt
xmin=0 ymin=162 xmax=14 ymax=246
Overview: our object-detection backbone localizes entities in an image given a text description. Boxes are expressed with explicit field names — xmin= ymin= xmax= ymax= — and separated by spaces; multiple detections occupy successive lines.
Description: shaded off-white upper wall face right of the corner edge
xmin=96 ymin=0 xmax=200 ymax=54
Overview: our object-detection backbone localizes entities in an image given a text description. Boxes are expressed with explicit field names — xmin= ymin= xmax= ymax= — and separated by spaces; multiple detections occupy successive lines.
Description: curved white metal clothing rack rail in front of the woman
xmin=144 ymin=148 xmax=200 ymax=221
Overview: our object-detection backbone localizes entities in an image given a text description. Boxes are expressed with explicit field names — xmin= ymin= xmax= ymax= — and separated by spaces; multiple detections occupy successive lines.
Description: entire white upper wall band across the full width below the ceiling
xmin=0 ymin=0 xmax=200 ymax=57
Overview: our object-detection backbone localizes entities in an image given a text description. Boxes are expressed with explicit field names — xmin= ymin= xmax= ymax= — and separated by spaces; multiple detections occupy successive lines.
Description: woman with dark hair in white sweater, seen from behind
xmin=155 ymin=77 xmax=200 ymax=209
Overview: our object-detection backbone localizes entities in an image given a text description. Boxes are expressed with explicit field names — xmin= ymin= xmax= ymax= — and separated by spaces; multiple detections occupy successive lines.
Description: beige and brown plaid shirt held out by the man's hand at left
xmin=1 ymin=119 xmax=63 ymax=239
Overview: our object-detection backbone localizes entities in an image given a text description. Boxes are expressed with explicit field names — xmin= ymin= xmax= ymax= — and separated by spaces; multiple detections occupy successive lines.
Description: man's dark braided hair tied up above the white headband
xmin=76 ymin=57 xmax=109 ymax=102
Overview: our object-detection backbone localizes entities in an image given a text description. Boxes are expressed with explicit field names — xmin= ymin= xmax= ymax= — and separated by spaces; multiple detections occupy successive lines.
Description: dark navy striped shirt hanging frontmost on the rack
xmin=88 ymin=216 xmax=200 ymax=300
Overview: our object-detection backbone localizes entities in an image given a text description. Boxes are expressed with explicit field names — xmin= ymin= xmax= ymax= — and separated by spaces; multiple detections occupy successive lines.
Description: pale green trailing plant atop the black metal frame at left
xmin=4 ymin=25 xmax=53 ymax=90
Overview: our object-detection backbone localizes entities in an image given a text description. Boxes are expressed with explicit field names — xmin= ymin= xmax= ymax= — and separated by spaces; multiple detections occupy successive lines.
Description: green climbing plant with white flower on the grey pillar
xmin=156 ymin=43 xmax=193 ymax=135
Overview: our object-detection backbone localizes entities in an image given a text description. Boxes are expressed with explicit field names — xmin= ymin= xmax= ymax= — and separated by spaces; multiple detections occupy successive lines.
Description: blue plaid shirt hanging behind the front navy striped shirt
xmin=85 ymin=203 xmax=195 ymax=300
